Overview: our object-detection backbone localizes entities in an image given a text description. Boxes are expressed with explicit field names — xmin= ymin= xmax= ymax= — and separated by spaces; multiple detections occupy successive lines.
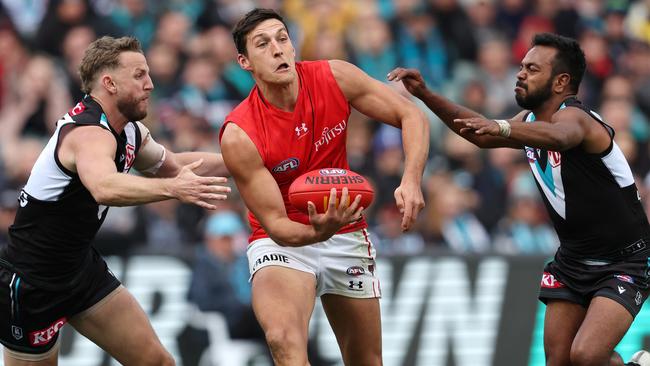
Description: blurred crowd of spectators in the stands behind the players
xmin=0 ymin=0 xmax=650 ymax=268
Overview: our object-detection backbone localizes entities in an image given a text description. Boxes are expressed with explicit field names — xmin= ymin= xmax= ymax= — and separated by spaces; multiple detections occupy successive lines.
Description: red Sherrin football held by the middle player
xmin=289 ymin=168 xmax=375 ymax=213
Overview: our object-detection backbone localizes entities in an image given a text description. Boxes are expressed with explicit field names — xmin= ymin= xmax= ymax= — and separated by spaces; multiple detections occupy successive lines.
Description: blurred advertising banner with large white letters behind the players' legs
xmin=0 ymin=255 xmax=650 ymax=366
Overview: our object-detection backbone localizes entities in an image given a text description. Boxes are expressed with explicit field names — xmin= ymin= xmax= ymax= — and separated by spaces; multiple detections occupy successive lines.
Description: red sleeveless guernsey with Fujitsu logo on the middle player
xmin=219 ymin=61 xmax=367 ymax=242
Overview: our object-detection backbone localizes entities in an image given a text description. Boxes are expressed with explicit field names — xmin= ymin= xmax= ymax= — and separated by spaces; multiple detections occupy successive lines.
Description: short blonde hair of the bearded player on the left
xmin=79 ymin=36 xmax=143 ymax=94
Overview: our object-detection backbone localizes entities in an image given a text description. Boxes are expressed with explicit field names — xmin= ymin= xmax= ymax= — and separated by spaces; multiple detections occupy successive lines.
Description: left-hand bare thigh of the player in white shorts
xmin=252 ymin=266 xmax=316 ymax=340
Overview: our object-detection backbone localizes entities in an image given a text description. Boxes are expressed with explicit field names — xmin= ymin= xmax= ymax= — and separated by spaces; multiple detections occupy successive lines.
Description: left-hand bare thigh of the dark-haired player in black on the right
xmin=544 ymin=300 xmax=587 ymax=366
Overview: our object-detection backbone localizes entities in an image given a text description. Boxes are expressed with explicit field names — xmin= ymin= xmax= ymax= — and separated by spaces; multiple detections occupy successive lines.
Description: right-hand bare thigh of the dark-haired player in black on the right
xmin=572 ymin=296 xmax=634 ymax=359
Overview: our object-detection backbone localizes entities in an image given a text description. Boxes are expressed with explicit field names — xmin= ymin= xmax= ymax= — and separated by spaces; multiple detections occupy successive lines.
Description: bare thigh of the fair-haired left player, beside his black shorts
xmin=70 ymin=286 xmax=170 ymax=365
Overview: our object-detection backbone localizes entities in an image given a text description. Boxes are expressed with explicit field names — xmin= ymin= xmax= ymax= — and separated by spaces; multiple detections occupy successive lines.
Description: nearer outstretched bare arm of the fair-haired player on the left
xmin=59 ymin=126 xmax=230 ymax=209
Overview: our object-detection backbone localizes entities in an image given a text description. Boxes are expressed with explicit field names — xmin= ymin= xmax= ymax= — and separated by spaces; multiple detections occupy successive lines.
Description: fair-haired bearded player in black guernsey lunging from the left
xmin=0 ymin=37 xmax=229 ymax=366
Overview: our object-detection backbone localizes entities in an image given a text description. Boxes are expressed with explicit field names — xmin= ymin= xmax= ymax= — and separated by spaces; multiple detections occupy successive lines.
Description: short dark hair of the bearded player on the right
xmin=533 ymin=33 xmax=587 ymax=93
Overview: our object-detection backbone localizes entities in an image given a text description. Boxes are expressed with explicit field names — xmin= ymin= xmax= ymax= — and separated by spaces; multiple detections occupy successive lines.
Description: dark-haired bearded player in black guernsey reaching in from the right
xmin=388 ymin=33 xmax=650 ymax=366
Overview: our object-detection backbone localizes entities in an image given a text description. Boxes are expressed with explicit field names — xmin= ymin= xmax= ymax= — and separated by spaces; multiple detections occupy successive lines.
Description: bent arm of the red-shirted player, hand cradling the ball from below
xmin=221 ymin=123 xmax=362 ymax=246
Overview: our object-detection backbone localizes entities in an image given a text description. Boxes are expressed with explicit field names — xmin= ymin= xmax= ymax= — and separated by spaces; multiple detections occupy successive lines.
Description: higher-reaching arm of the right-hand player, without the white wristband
xmin=388 ymin=67 xmax=522 ymax=149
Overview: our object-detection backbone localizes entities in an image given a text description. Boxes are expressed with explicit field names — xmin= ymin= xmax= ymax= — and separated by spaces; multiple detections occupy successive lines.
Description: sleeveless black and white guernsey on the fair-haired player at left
xmin=0 ymin=96 xmax=141 ymax=288
